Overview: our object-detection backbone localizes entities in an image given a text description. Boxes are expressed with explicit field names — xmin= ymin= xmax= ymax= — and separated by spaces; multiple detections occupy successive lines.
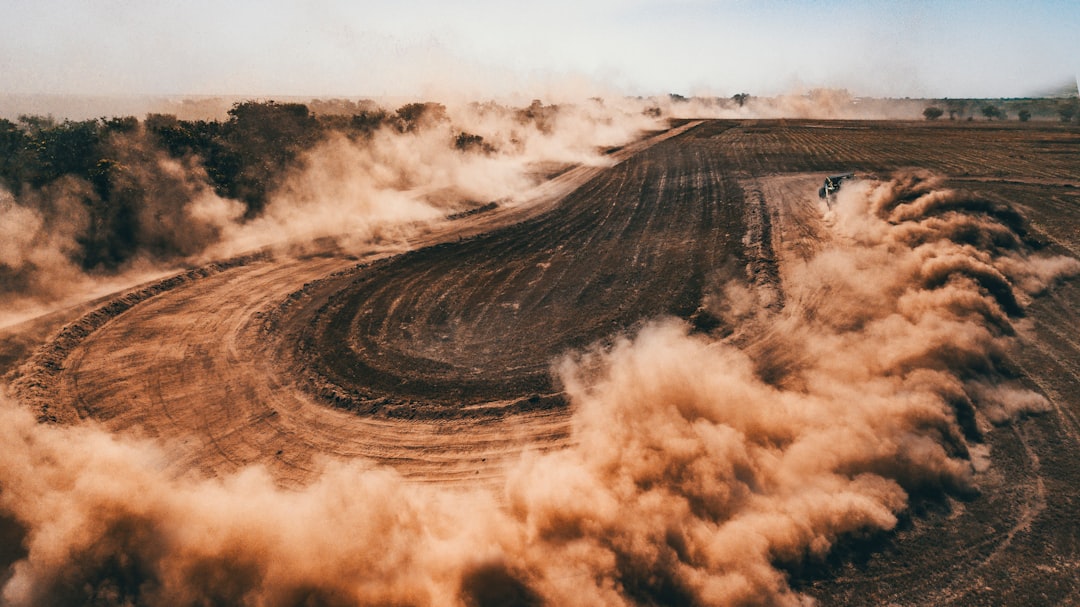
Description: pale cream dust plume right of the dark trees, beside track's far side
xmin=207 ymin=100 xmax=660 ymax=257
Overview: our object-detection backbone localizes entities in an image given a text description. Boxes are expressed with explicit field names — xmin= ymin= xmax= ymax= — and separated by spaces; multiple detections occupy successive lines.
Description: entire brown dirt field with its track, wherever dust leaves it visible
xmin=4 ymin=121 xmax=1080 ymax=605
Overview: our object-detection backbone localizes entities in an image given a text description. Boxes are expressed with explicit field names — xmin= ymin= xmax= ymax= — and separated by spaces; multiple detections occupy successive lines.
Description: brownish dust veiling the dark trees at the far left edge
xmin=0 ymin=121 xmax=243 ymax=326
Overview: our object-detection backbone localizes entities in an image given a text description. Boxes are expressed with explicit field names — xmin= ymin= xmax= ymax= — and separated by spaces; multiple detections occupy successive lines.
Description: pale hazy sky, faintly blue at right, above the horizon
xmin=0 ymin=0 xmax=1080 ymax=97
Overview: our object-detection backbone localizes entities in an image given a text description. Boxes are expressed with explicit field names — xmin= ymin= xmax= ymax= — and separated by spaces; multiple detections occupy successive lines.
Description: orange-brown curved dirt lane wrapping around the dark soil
xmin=19 ymin=124 xmax=717 ymax=486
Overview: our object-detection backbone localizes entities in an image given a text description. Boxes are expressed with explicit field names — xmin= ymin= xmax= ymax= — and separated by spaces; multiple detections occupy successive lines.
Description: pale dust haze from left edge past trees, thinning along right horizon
xmin=0 ymin=90 xmax=921 ymax=326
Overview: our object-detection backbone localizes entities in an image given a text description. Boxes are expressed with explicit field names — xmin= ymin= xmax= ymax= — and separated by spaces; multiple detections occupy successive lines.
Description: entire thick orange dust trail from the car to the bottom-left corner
xmin=0 ymin=168 xmax=1080 ymax=606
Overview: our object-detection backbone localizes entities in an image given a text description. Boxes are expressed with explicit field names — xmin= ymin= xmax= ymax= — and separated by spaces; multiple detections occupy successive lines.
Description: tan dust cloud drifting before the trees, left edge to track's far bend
xmin=0 ymin=99 xmax=662 ymax=326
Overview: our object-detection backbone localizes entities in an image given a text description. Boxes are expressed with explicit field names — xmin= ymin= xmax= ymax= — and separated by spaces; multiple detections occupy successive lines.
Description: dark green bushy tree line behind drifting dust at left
xmin=0 ymin=100 xmax=518 ymax=270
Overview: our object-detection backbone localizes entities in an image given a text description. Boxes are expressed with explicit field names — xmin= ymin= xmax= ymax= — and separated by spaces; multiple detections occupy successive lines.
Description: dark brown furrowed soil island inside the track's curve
xmin=278 ymin=123 xmax=744 ymax=417
